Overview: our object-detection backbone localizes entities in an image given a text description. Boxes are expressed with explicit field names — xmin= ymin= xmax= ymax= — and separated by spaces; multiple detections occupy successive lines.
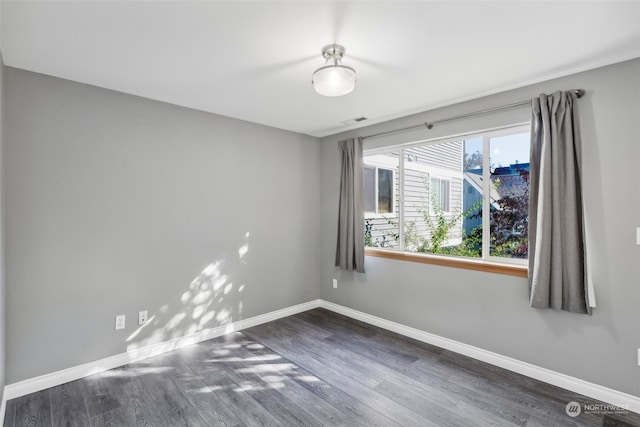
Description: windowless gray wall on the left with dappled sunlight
xmin=3 ymin=68 xmax=320 ymax=384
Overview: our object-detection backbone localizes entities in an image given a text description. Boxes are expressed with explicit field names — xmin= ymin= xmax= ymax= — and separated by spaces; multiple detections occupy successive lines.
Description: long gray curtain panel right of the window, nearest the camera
xmin=529 ymin=92 xmax=591 ymax=314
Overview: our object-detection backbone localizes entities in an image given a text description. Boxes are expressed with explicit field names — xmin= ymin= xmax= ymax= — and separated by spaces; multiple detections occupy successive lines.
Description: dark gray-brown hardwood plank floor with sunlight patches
xmin=4 ymin=309 xmax=640 ymax=427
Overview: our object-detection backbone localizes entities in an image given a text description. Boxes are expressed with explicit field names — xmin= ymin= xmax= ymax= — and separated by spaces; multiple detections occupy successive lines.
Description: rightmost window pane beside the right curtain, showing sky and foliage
xmin=489 ymin=133 xmax=530 ymax=258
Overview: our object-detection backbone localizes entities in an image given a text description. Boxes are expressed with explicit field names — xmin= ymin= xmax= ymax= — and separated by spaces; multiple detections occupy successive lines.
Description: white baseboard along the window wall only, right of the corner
xmin=320 ymin=300 xmax=640 ymax=413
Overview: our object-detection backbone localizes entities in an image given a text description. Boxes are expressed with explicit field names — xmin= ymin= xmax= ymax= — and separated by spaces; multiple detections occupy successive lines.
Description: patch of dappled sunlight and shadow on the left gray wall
xmin=126 ymin=232 xmax=250 ymax=354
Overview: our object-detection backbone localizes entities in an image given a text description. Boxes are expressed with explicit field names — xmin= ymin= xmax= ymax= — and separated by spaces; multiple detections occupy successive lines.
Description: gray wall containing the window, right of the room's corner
xmin=321 ymin=60 xmax=640 ymax=396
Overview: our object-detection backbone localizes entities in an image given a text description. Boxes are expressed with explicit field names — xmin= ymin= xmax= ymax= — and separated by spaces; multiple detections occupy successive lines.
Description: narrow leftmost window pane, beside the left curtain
xmin=364 ymin=151 xmax=400 ymax=249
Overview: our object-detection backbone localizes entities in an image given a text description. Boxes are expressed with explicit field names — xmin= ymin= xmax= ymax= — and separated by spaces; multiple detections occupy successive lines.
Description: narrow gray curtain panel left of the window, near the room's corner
xmin=336 ymin=138 xmax=364 ymax=273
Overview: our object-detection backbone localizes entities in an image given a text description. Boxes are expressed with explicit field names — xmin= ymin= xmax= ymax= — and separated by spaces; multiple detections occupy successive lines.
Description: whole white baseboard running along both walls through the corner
xmin=0 ymin=299 xmax=640 ymax=421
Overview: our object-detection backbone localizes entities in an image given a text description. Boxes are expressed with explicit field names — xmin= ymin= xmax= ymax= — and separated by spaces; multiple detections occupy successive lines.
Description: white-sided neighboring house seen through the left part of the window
xmin=364 ymin=141 xmax=463 ymax=250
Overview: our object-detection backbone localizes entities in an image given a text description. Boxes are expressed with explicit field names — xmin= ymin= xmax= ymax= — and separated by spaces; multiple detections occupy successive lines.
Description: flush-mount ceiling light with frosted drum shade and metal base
xmin=311 ymin=44 xmax=356 ymax=96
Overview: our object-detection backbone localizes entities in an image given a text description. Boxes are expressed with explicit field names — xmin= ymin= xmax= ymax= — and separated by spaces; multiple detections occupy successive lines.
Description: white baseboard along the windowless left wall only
xmin=0 ymin=300 xmax=321 ymax=402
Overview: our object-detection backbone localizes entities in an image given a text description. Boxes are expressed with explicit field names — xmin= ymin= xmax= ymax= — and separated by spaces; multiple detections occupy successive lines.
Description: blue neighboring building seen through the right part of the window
xmin=463 ymin=163 xmax=530 ymax=234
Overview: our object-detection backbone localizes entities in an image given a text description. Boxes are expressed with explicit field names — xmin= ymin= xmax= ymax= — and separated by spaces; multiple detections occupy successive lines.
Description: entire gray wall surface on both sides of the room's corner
xmin=5 ymin=55 xmax=640 ymax=395
